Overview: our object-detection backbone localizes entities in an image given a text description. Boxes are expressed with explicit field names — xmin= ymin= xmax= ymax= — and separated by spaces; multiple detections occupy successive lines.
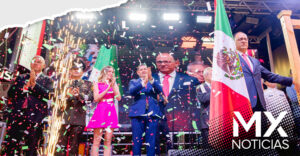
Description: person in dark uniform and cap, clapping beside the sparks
xmin=55 ymin=58 xmax=93 ymax=155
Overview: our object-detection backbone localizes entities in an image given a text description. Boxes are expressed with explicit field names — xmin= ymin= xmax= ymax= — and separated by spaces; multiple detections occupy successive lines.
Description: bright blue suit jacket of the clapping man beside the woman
xmin=129 ymin=79 xmax=162 ymax=117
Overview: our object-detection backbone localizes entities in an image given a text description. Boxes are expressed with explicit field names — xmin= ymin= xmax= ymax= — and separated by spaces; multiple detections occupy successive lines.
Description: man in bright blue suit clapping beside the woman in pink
xmin=129 ymin=64 xmax=162 ymax=156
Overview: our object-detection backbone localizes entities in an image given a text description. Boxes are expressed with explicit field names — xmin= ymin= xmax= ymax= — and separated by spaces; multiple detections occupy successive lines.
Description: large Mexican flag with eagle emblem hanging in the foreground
xmin=209 ymin=0 xmax=253 ymax=148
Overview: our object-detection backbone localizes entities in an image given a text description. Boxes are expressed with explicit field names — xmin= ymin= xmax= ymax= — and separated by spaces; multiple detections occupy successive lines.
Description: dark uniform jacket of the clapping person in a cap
xmin=64 ymin=80 xmax=94 ymax=126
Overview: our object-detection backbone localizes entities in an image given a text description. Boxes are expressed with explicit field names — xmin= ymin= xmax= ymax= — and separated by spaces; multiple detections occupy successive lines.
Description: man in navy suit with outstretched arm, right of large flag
xmin=234 ymin=32 xmax=293 ymax=111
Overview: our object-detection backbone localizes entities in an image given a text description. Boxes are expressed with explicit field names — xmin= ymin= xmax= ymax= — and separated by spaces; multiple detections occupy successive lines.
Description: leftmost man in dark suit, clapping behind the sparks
xmin=5 ymin=56 xmax=52 ymax=156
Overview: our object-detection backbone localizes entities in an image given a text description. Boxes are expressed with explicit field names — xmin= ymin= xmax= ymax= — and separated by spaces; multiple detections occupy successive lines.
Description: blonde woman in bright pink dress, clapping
xmin=87 ymin=66 xmax=121 ymax=156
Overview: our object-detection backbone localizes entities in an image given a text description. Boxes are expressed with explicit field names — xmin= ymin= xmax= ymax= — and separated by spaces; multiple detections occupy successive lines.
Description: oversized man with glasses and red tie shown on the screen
xmin=153 ymin=53 xmax=199 ymax=154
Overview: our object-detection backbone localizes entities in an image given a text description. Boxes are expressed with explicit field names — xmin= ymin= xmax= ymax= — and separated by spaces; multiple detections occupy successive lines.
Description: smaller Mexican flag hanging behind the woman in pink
xmin=89 ymin=45 xmax=123 ymax=95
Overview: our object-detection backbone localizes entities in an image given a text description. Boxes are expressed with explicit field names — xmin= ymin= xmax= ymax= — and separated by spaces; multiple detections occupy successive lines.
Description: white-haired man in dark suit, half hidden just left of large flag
xmin=197 ymin=67 xmax=212 ymax=148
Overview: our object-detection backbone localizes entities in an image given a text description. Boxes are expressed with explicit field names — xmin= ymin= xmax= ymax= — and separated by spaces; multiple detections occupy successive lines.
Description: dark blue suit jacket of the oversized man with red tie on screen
xmin=153 ymin=72 xmax=200 ymax=131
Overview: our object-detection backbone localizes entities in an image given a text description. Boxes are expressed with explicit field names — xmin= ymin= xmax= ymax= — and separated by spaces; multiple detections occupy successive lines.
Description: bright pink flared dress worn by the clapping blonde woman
xmin=87 ymin=83 xmax=119 ymax=128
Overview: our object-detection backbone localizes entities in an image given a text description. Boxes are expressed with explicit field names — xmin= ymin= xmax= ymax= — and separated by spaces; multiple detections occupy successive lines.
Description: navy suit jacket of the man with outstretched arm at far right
xmin=240 ymin=56 xmax=293 ymax=110
